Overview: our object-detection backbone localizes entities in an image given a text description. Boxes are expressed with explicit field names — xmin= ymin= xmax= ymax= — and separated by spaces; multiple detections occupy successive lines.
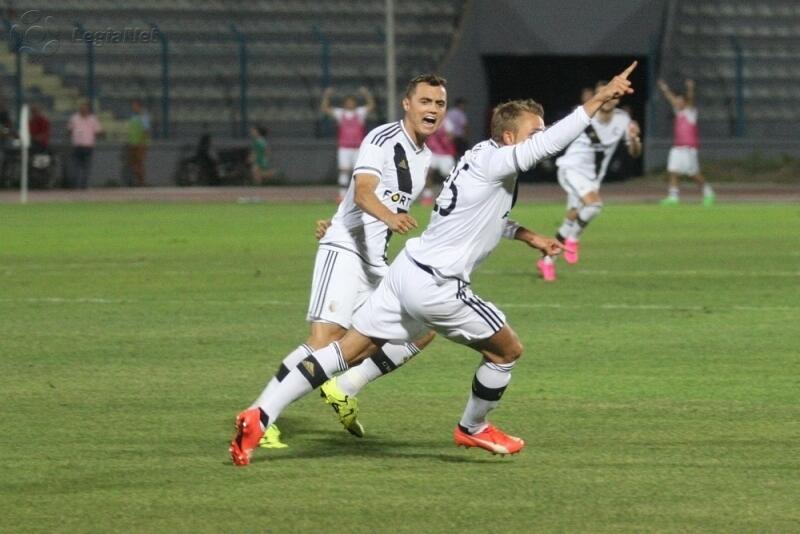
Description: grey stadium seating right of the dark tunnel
xmin=662 ymin=0 xmax=800 ymax=137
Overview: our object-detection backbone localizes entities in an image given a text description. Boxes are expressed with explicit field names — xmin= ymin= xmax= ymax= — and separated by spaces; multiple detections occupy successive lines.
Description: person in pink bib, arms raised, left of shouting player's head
xmin=320 ymin=87 xmax=375 ymax=202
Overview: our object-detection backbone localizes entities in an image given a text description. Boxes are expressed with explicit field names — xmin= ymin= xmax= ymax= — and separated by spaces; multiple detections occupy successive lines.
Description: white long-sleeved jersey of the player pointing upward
xmin=405 ymin=107 xmax=589 ymax=283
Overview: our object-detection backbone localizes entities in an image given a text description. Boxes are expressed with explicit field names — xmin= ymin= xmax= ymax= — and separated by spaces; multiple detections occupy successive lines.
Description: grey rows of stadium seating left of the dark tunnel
xmin=0 ymin=0 xmax=465 ymax=137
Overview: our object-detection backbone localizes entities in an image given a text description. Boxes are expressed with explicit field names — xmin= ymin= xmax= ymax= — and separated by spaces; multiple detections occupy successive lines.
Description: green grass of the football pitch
xmin=0 ymin=204 xmax=800 ymax=532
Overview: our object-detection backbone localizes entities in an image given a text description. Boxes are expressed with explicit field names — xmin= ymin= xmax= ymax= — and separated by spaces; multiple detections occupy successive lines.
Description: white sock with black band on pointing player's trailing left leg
xmin=258 ymin=342 xmax=347 ymax=424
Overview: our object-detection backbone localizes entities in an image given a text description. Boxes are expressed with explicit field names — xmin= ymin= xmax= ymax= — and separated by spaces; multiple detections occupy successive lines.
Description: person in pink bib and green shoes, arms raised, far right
xmin=658 ymin=80 xmax=714 ymax=206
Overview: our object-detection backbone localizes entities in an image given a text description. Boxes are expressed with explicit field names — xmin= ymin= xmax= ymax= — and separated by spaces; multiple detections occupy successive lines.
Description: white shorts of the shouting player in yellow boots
xmin=306 ymin=245 xmax=388 ymax=328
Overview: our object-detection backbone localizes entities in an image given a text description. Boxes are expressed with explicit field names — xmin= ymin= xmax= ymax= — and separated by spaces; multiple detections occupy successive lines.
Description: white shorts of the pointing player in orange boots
xmin=353 ymin=251 xmax=506 ymax=345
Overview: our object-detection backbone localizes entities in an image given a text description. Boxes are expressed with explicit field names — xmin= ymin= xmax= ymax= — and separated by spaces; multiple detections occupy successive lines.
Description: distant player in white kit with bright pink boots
xmin=536 ymin=82 xmax=642 ymax=282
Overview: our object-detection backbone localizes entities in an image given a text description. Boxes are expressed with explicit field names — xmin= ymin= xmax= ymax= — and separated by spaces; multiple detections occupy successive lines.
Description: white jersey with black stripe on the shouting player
xmin=320 ymin=120 xmax=431 ymax=274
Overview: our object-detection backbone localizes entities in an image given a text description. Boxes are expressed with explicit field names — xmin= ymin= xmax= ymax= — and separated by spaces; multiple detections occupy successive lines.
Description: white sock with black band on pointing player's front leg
xmin=459 ymin=360 xmax=515 ymax=434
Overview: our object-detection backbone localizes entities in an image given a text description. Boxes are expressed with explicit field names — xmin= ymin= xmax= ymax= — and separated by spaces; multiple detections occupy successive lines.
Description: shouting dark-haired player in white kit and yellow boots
xmin=247 ymin=75 xmax=447 ymax=448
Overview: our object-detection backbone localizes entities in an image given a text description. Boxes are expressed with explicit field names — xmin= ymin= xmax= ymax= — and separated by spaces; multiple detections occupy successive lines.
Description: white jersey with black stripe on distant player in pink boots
xmin=556 ymin=109 xmax=631 ymax=180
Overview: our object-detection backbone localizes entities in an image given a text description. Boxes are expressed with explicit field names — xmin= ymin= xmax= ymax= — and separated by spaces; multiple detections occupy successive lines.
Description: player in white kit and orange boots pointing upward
xmin=230 ymin=63 xmax=636 ymax=465
